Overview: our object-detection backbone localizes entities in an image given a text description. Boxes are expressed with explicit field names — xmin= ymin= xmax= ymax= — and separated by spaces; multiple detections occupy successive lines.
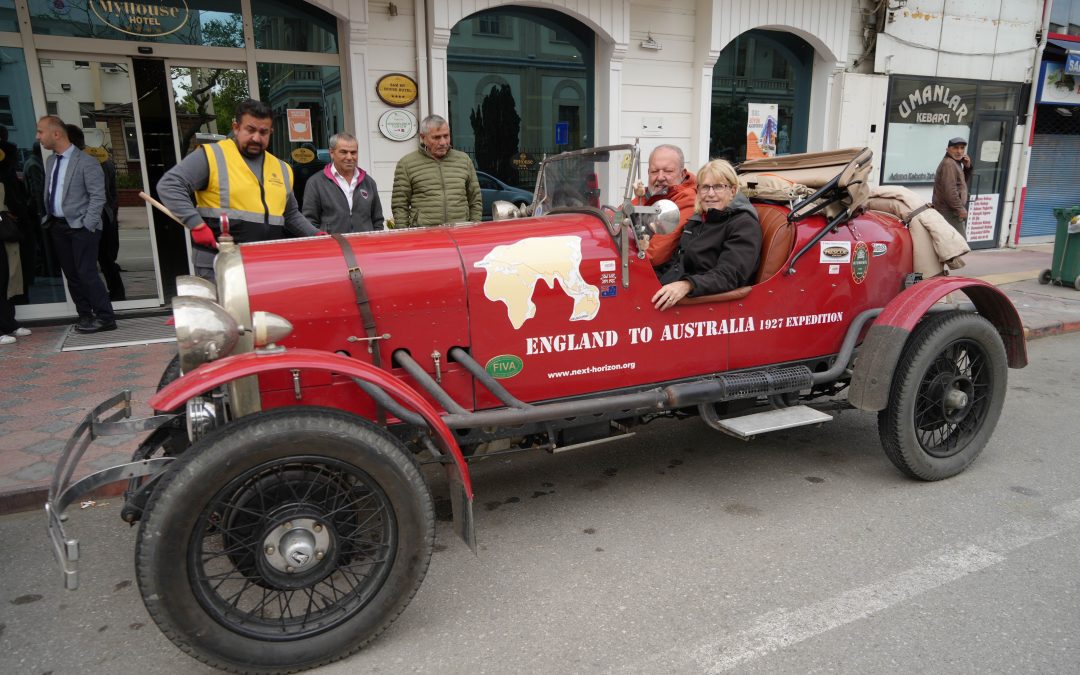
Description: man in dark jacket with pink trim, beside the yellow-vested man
xmin=303 ymin=132 xmax=383 ymax=234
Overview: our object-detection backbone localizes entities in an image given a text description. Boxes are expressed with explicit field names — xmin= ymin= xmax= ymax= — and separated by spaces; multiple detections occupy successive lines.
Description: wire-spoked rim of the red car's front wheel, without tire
xmin=189 ymin=457 xmax=397 ymax=639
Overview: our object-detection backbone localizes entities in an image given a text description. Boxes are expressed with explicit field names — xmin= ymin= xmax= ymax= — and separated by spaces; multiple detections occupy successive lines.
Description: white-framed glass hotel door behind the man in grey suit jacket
xmin=28 ymin=52 xmax=162 ymax=316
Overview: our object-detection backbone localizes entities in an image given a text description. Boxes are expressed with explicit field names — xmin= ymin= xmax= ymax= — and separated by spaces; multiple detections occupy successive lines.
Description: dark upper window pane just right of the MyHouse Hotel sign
xmin=252 ymin=0 xmax=338 ymax=54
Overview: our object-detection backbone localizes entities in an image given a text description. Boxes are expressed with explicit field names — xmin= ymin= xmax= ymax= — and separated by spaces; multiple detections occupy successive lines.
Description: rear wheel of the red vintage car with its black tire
xmin=878 ymin=312 xmax=1009 ymax=481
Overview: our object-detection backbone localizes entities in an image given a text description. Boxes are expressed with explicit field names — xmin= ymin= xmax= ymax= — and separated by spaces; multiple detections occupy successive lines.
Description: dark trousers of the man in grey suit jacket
xmin=49 ymin=218 xmax=116 ymax=321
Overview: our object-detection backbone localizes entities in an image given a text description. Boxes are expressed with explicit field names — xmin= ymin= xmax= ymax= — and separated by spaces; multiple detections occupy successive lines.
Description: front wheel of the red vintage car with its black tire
xmin=135 ymin=407 xmax=435 ymax=673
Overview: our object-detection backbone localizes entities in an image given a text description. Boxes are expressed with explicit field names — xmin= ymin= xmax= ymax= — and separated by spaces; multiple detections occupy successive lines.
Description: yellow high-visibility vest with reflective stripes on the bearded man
xmin=195 ymin=138 xmax=293 ymax=227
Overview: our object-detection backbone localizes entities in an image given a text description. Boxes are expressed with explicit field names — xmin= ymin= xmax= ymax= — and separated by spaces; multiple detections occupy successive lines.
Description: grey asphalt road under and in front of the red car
xmin=0 ymin=334 xmax=1080 ymax=675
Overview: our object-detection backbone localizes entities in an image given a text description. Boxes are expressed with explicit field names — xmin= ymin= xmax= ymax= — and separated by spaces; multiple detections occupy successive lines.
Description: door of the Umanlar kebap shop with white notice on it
xmin=968 ymin=112 xmax=1014 ymax=248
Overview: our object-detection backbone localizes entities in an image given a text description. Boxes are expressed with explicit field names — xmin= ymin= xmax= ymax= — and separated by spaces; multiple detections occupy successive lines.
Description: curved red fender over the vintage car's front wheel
xmin=149 ymin=348 xmax=475 ymax=551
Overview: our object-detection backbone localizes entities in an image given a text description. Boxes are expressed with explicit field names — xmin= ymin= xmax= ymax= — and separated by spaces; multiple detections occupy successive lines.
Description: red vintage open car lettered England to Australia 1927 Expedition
xmin=46 ymin=146 xmax=1026 ymax=672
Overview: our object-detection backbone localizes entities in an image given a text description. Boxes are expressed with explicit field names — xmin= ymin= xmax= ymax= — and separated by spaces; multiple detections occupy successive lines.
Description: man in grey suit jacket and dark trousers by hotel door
xmin=37 ymin=114 xmax=117 ymax=333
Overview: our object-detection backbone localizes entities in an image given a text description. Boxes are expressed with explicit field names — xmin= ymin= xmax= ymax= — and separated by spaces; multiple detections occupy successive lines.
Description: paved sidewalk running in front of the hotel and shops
xmin=0 ymin=244 xmax=1080 ymax=514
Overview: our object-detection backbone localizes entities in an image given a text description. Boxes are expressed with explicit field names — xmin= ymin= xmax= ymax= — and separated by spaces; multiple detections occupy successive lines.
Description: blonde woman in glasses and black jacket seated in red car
xmin=652 ymin=160 xmax=761 ymax=310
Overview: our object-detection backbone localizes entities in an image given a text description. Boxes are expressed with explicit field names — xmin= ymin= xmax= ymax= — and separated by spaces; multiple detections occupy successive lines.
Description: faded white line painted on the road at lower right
xmin=639 ymin=492 xmax=1080 ymax=673
